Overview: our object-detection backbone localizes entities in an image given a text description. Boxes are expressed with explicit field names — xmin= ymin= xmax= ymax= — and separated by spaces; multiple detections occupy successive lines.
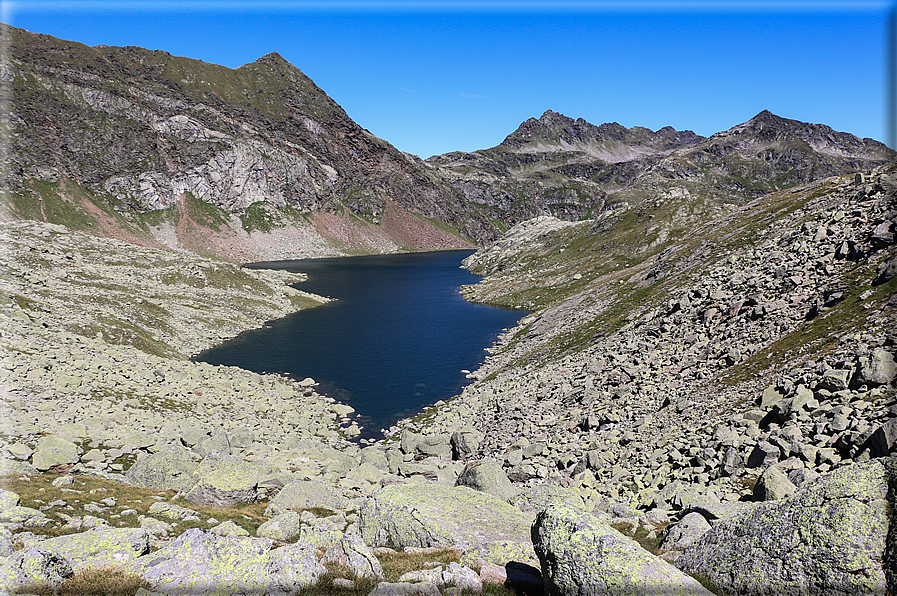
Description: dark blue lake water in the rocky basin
xmin=196 ymin=250 xmax=525 ymax=438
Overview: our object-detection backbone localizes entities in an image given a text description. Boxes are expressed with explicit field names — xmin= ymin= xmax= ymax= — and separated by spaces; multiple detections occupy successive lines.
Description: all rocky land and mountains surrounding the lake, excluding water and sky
xmin=0 ymin=26 xmax=897 ymax=596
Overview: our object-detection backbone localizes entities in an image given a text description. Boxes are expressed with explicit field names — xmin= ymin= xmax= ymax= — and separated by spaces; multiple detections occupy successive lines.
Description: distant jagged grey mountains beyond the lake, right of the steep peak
xmin=427 ymin=110 xmax=895 ymax=258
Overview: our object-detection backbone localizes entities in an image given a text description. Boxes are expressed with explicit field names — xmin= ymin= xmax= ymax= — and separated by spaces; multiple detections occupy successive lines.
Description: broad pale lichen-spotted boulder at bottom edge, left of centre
xmin=121 ymin=528 xmax=326 ymax=595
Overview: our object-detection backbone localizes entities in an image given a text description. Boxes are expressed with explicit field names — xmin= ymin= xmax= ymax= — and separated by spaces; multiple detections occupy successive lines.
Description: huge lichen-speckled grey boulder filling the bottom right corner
xmin=676 ymin=460 xmax=894 ymax=596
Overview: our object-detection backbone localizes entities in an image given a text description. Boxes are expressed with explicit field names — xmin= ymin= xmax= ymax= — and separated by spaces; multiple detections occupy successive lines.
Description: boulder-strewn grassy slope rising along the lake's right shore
xmin=408 ymin=166 xmax=897 ymax=498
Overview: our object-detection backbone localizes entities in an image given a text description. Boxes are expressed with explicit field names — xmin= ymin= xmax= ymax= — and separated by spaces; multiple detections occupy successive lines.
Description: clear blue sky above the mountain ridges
xmin=0 ymin=0 xmax=894 ymax=157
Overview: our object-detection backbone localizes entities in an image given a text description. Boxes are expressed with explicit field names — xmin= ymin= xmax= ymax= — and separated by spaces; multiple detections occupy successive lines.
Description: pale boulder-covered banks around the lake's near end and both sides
xmin=0 ymin=168 xmax=897 ymax=595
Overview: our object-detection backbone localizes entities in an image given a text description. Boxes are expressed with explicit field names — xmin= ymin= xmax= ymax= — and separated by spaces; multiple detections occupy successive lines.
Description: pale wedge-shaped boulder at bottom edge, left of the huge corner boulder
xmin=532 ymin=505 xmax=710 ymax=596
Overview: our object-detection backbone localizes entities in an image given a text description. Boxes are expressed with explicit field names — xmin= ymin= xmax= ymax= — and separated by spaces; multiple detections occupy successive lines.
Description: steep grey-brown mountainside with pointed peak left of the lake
xmin=0 ymin=25 xmax=495 ymax=260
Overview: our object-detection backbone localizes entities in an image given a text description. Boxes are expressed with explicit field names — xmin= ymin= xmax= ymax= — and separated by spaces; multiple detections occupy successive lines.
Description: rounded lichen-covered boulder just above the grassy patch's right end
xmin=184 ymin=451 xmax=258 ymax=507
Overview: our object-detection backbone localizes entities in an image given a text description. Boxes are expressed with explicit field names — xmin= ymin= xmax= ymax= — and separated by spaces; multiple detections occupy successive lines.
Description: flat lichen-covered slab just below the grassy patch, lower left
xmin=28 ymin=527 xmax=150 ymax=572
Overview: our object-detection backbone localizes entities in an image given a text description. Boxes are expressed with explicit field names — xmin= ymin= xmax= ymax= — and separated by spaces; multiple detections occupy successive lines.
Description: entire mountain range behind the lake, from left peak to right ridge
xmin=0 ymin=25 xmax=895 ymax=260
